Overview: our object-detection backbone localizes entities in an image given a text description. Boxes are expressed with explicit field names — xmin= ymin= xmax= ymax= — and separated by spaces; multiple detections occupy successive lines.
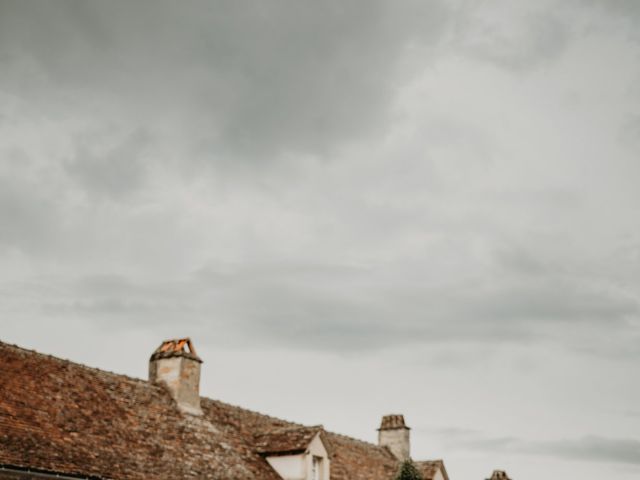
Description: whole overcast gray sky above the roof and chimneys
xmin=0 ymin=0 xmax=640 ymax=480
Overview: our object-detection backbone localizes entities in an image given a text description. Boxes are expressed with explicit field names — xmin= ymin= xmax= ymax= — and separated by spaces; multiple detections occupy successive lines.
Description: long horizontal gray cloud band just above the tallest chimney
xmin=17 ymin=251 xmax=640 ymax=355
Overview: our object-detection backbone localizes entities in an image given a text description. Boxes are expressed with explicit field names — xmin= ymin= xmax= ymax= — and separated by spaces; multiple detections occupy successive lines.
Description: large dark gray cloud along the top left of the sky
xmin=0 ymin=1 xmax=447 ymax=160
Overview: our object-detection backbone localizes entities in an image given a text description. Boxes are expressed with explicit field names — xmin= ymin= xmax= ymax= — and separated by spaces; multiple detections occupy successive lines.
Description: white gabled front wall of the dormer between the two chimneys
xmin=267 ymin=434 xmax=330 ymax=480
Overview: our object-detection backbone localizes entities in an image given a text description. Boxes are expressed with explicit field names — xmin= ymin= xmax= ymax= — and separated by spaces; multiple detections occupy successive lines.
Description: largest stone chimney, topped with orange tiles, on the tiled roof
xmin=149 ymin=338 xmax=202 ymax=415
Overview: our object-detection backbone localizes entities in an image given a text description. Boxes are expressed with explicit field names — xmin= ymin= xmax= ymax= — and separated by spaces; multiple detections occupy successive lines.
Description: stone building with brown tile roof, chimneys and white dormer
xmin=0 ymin=339 xmax=448 ymax=480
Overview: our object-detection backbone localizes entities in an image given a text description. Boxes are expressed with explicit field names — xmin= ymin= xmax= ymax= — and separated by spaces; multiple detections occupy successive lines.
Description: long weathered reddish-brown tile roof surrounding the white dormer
xmin=0 ymin=342 xmax=450 ymax=480
